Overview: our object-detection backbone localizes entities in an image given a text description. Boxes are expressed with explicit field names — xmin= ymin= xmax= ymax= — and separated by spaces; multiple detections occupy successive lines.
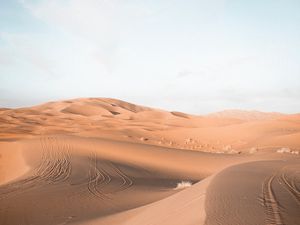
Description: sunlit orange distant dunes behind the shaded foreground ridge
xmin=0 ymin=98 xmax=300 ymax=152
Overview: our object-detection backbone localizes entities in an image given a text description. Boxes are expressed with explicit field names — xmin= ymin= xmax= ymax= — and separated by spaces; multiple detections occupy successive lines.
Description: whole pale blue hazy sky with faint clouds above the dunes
xmin=0 ymin=0 xmax=300 ymax=114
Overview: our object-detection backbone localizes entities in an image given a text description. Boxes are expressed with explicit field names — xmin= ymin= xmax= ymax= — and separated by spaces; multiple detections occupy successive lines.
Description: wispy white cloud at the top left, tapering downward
xmin=22 ymin=0 xmax=172 ymax=72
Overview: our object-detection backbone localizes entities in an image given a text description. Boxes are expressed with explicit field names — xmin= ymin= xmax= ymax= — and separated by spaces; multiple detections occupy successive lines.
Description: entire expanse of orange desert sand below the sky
xmin=0 ymin=98 xmax=300 ymax=225
